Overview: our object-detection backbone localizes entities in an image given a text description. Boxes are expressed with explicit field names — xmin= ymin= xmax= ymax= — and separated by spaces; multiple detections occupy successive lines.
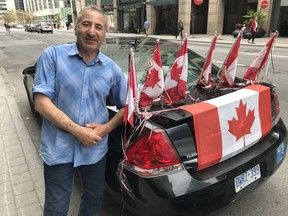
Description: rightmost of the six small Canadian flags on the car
xmin=243 ymin=32 xmax=278 ymax=81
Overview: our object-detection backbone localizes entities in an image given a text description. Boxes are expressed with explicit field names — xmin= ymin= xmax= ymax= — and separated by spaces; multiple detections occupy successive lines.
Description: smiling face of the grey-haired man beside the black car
xmin=75 ymin=11 xmax=106 ymax=52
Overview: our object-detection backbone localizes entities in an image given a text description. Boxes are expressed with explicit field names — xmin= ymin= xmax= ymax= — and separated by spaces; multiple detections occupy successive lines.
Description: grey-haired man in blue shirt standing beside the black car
xmin=33 ymin=5 xmax=127 ymax=216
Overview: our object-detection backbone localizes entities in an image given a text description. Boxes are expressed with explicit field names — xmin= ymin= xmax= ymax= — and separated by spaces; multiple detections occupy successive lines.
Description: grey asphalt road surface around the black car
xmin=0 ymin=27 xmax=288 ymax=216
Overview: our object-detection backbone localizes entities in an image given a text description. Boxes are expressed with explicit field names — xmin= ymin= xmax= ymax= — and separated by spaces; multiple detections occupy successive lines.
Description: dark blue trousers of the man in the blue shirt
xmin=44 ymin=156 xmax=106 ymax=216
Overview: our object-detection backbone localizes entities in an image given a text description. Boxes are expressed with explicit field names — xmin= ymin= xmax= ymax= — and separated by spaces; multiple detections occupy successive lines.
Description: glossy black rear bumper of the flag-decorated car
xmin=116 ymin=119 xmax=288 ymax=216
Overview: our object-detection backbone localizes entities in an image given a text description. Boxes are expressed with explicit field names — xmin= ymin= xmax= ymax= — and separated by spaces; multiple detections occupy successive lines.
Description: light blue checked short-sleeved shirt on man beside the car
xmin=33 ymin=43 xmax=127 ymax=167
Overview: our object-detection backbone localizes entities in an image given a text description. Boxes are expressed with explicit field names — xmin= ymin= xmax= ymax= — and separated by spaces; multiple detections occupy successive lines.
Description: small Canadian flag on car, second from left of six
xmin=139 ymin=39 xmax=164 ymax=107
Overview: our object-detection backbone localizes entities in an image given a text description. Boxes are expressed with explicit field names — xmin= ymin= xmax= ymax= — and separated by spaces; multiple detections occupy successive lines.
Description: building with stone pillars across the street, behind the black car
xmin=79 ymin=0 xmax=288 ymax=36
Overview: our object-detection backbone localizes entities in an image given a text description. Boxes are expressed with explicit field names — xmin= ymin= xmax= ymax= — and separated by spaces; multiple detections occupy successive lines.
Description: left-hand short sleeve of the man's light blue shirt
xmin=33 ymin=47 xmax=56 ymax=100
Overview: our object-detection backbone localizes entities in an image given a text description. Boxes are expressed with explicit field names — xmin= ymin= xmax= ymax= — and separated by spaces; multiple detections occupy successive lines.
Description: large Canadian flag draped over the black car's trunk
xmin=181 ymin=85 xmax=272 ymax=170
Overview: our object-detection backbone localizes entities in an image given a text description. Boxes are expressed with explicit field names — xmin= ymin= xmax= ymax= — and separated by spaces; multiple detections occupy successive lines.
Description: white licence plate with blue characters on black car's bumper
xmin=234 ymin=164 xmax=261 ymax=193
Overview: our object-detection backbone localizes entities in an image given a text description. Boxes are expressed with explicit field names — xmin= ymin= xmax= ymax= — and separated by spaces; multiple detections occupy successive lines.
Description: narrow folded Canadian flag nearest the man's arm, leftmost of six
xmin=123 ymin=50 xmax=138 ymax=127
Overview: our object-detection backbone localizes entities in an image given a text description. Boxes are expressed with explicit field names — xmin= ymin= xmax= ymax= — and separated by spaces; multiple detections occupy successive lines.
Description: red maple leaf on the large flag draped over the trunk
xmin=228 ymin=100 xmax=255 ymax=146
